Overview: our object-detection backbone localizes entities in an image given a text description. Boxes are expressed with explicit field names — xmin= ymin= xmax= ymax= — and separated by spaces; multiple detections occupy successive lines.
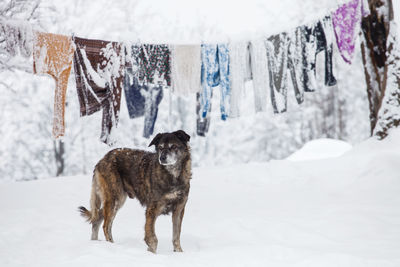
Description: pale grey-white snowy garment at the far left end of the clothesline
xmin=0 ymin=20 xmax=33 ymax=57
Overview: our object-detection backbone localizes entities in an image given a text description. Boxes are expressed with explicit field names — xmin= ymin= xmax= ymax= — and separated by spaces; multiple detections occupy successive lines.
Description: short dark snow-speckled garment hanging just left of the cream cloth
xmin=138 ymin=44 xmax=171 ymax=86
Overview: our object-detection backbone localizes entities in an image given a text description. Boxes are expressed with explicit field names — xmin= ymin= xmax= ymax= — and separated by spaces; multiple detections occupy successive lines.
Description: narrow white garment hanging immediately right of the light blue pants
xmin=229 ymin=42 xmax=251 ymax=118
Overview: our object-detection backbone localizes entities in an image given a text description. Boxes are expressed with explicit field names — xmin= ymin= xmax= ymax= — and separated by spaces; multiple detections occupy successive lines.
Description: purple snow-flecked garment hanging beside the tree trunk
xmin=332 ymin=0 xmax=369 ymax=64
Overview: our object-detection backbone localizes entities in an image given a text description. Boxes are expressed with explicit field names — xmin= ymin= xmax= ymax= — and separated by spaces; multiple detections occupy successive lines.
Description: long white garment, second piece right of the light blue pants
xmin=249 ymin=39 xmax=269 ymax=112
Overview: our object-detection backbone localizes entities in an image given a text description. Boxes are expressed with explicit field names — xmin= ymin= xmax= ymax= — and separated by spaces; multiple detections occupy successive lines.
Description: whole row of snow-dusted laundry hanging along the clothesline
xmin=0 ymin=0 xmax=369 ymax=144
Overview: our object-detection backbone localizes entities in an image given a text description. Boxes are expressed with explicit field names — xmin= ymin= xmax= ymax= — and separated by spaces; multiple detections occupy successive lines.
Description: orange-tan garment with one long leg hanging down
xmin=33 ymin=32 xmax=74 ymax=138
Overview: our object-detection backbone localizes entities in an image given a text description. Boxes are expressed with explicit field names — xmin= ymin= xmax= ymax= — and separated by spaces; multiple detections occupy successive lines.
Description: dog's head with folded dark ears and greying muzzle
xmin=149 ymin=130 xmax=190 ymax=165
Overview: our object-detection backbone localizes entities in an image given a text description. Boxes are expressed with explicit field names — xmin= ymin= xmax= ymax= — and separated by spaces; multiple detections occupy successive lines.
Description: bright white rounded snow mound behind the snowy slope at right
xmin=286 ymin=138 xmax=352 ymax=161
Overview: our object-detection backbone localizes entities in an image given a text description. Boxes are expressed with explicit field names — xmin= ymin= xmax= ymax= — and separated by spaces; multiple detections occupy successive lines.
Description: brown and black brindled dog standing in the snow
xmin=79 ymin=130 xmax=192 ymax=253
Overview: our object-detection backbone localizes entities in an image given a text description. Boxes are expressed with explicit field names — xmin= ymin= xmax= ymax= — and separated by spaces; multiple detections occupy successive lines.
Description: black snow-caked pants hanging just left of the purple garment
xmin=302 ymin=16 xmax=337 ymax=92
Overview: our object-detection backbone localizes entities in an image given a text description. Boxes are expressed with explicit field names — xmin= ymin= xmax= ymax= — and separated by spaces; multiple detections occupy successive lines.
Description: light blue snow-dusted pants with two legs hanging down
xmin=199 ymin=44 xmax=230 ymax=120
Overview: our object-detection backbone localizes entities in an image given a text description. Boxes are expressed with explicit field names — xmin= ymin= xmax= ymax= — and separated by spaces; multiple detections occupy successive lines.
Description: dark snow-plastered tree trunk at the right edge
xmin=361 ymin=0 xmax=400 ymax=138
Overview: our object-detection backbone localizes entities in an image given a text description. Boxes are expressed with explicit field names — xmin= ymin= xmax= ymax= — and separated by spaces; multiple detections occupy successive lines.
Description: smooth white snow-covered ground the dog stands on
xmin=0 ymin=130 xmax=400 ymax=267
